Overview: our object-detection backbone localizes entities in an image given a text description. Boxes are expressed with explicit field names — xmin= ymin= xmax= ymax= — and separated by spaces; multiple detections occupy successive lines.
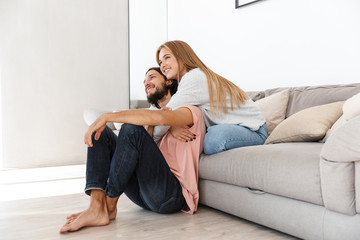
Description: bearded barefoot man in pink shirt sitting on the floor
xmin=60 ymin=68 xmax=205 ymax=232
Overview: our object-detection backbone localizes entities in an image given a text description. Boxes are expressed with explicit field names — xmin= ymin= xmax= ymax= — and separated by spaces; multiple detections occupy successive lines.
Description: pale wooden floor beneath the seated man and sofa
xmin=0 ymin=167 xmax=296 ymax=240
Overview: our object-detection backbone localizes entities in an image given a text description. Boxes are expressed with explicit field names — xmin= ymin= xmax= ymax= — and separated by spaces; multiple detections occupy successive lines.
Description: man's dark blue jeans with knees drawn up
xmin=85 ymin=124 xmax=185 ymax=213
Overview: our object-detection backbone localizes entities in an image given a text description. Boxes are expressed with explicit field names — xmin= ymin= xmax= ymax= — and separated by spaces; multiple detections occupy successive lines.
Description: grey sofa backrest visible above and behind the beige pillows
xmin=248 ymin=83 xmax=360 ymax=118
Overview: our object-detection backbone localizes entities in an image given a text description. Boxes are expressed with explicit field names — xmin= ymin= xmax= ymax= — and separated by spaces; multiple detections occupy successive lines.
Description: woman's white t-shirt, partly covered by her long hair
xmin=153 ymin=68 xmax=265 ymax=142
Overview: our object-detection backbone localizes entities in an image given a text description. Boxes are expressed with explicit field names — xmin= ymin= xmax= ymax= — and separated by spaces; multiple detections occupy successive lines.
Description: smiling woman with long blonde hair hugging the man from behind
xmin=154 ymin=41 xmax=268 ymax=154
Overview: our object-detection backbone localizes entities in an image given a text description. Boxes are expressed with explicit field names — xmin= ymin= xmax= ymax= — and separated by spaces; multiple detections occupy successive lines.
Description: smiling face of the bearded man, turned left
xmin=144 ymin=70 xmax=171 ymax=105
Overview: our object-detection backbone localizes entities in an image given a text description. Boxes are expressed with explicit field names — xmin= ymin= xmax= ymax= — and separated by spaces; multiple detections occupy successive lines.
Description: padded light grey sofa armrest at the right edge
xmin=320 ymin=117 xmax=360 ymax=215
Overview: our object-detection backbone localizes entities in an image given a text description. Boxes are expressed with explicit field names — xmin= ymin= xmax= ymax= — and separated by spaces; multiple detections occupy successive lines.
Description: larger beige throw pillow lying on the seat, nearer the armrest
xmin=265 ymin=102 xmax=344 ymax=144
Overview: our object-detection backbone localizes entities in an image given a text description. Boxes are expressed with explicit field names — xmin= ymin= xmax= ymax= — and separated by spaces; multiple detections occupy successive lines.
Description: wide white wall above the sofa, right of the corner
xmin=168 ymin=0 xmax=360 ymax=90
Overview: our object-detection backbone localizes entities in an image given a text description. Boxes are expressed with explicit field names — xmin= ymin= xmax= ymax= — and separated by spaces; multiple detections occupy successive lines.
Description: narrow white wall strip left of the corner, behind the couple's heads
xmin=129 ymin=0 xmax=167 ymax=100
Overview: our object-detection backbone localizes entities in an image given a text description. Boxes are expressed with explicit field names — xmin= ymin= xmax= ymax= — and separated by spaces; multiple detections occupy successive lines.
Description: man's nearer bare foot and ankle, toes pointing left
xmin=60 ymin=191 xmax=110 ymax=233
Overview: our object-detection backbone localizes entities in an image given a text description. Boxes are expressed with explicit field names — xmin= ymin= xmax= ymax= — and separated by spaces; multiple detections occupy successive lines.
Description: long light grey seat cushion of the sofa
xmin=199 ymin=142 xmax=323 ymax=206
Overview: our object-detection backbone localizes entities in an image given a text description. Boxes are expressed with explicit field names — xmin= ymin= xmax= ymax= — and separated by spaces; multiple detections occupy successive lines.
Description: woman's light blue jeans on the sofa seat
xmin=204 ymin=123 xmax=268 ymax=155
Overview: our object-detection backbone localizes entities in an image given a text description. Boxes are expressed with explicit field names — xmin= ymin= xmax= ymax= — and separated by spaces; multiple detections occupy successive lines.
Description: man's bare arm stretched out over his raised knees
xmin=84 ymin=107 xmax=193 ymax=147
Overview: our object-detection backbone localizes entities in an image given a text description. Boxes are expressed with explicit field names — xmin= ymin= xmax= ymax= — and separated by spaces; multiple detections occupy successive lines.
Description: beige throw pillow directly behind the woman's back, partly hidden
xmin=255 ymin=89 xmax=290 ymax=135
